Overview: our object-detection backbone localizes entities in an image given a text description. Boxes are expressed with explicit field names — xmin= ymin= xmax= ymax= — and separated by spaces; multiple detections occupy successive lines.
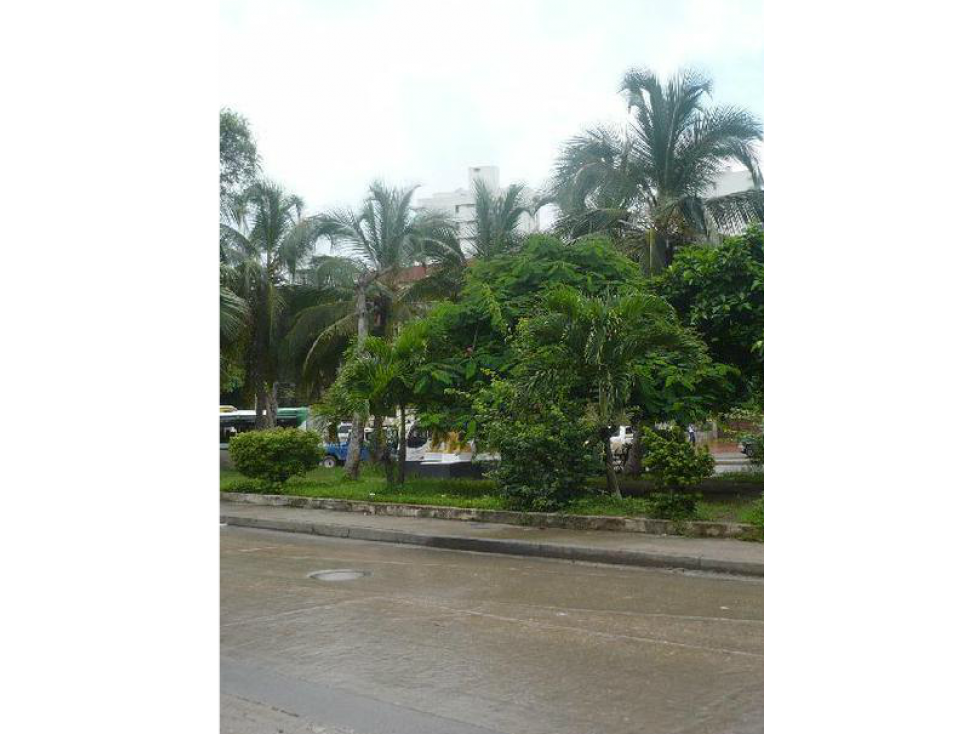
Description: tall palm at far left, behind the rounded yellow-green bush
xmin=221 ymin=181 xmax=330 ymax=428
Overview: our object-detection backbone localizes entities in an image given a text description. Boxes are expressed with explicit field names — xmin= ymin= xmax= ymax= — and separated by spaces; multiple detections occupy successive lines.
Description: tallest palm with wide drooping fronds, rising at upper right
xmin=552 ymin=70 xmax=764 ymax=272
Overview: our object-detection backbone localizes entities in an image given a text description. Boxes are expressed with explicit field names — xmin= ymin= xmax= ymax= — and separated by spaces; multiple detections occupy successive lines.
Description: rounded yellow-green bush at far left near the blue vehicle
xmin=228 ymin=428 xmax=323 ymax=489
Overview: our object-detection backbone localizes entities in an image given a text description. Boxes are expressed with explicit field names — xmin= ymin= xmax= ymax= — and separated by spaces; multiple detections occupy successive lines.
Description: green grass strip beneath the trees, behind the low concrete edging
xmin=221 ymin=467 xmax=754 ymax=522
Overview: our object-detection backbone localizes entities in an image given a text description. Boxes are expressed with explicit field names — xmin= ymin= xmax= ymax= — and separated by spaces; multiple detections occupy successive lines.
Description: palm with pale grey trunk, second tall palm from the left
xmin=306 ymin=181 xmax=458 ymax=478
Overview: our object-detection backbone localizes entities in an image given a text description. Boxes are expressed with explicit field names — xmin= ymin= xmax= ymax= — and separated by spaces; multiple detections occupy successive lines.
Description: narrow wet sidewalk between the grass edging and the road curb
xmin=221 ymin=501 xmax=765 ymax=576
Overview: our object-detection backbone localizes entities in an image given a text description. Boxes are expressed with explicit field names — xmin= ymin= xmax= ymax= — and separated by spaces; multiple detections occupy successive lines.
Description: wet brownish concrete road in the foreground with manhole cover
xmin=221 ymin=527 xmax=764 ymax=734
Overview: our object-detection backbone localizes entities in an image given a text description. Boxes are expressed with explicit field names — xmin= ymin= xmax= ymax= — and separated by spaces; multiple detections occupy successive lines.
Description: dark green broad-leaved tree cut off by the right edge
xmin=656 ymin=226 xmax=765 ymax=404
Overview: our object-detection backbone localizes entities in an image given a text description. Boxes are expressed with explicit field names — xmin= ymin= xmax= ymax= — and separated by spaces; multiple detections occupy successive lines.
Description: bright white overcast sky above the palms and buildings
xmin=216 ymin=0 xmax=765 ymax=216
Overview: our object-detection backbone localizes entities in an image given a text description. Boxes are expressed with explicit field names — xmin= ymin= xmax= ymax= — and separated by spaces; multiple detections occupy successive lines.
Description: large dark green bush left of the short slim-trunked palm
xmin=487 ymin=406 xmax=598 ymax=512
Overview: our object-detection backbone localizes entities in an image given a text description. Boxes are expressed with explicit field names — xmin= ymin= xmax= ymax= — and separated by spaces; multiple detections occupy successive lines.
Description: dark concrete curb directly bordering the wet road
xmin=221 ymin=515 xmax=765 ymax=577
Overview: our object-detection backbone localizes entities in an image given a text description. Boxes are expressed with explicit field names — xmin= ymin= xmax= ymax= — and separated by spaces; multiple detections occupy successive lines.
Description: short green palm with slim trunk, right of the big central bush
xmin=526 ymin=286 xmax=698 ymax=497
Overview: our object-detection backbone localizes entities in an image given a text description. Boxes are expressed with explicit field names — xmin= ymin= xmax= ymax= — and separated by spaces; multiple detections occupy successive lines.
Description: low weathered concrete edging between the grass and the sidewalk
xmin=221 ymin=492 xmax=752 ymax=538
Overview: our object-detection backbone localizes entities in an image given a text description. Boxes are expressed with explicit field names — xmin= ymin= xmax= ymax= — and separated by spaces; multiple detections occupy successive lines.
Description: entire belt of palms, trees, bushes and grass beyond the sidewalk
xmin=219 ymin=70 xmax=765 ymax=537
